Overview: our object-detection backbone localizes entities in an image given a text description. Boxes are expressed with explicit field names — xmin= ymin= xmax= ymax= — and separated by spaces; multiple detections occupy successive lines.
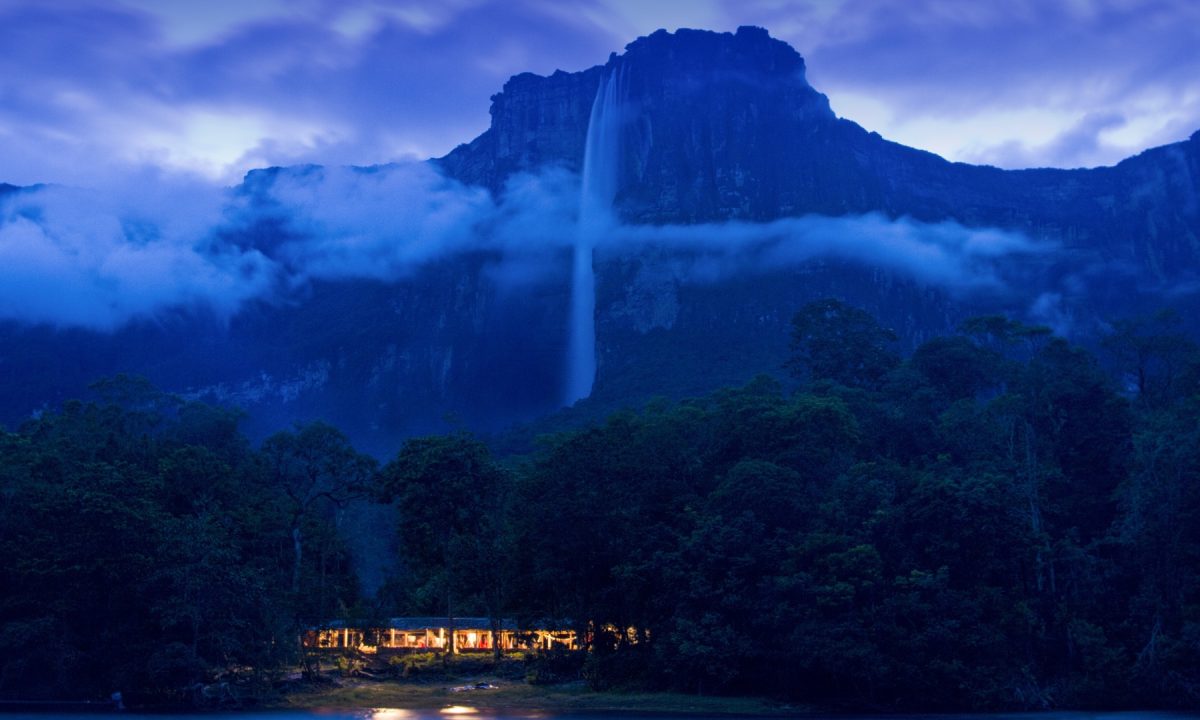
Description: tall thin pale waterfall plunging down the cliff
xmin=565 ymin=68 xmax=622 ymax=404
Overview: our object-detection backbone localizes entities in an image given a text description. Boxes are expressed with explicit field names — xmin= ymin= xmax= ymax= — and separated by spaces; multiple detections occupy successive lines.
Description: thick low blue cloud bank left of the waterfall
xmin=0 ymin=162 xmax=580 ymax=331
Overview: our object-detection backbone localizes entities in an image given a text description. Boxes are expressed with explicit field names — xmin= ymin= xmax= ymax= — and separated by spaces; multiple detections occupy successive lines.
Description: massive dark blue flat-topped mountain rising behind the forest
xmin=0 ymin=28 xmax=1200 ymax=455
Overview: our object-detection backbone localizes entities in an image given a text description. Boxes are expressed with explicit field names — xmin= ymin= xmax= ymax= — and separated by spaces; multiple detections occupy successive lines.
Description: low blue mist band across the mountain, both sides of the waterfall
xmin=0 ymin=162 xmax=1051 ymax=331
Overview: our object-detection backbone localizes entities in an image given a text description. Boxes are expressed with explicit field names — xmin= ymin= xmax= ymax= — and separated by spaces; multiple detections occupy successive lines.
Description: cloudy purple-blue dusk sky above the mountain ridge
xmin=0 ymin=0 xmax=1200 ymax=186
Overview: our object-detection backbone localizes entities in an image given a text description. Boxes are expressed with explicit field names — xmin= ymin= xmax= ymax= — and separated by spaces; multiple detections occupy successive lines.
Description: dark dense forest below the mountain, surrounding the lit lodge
xmin=0 ymin=300 xmax=1200 ymax=709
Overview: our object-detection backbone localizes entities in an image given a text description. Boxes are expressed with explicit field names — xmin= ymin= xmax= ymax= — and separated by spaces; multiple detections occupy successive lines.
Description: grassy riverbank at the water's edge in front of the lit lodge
xmin=270 ymin=678 xmax=806 ymax=716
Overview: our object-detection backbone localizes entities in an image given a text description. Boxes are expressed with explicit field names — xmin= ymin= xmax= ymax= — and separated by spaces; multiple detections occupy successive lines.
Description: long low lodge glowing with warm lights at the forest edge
xmin=302 ymin=618 xmax=580 ymax=653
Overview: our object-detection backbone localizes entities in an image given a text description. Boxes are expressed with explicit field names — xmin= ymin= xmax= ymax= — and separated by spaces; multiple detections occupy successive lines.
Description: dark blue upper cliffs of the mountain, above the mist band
xmin=439 ymin=28 xmax=1200 ymax=281
